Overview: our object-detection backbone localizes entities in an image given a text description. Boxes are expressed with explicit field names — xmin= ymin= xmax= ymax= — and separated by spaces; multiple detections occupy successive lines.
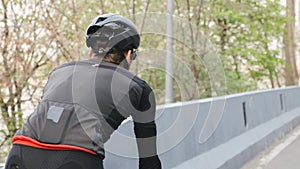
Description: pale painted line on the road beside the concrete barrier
xmin=256 ymin=128 xmax=300 ymax=169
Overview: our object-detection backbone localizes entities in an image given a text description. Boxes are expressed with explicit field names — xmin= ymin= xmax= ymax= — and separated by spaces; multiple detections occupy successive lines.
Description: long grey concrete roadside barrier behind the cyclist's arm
xmin=104 ymin=87 xmax=300 ymax=169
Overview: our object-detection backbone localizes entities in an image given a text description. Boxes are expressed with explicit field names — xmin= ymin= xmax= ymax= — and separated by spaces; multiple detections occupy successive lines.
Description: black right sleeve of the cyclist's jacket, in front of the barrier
xmin=132 ymin=84 xmax=161 ymax=169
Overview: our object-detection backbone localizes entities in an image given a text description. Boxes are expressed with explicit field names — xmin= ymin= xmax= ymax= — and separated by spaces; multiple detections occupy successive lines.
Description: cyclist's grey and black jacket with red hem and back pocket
xmin=14 ymin=59 xmax=160 ymax=168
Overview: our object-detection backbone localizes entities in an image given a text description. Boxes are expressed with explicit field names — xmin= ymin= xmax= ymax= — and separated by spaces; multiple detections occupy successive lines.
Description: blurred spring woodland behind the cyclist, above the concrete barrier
xmin=0 ymin=0 xmax=300 ymax=163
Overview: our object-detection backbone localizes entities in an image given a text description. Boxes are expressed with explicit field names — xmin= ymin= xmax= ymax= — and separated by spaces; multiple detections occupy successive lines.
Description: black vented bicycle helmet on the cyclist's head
xmin=86 ymin=14 xmax=140 ymax=58
